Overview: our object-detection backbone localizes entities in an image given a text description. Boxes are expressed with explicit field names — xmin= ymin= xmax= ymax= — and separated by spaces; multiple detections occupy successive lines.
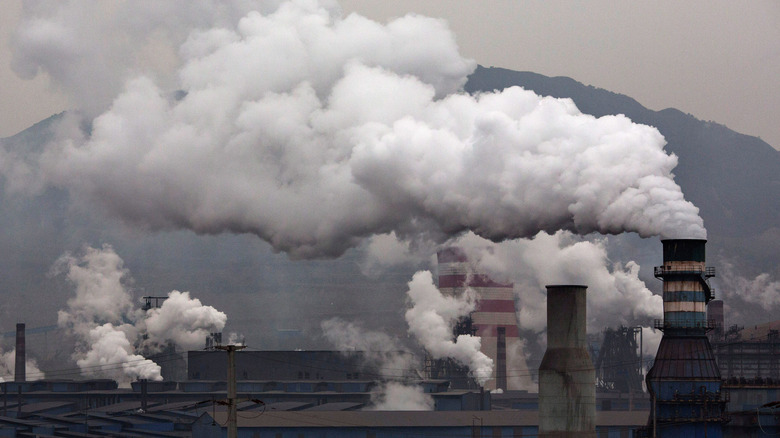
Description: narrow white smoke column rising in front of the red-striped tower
xmin=406 ymin=271 xmax=493 ymax=385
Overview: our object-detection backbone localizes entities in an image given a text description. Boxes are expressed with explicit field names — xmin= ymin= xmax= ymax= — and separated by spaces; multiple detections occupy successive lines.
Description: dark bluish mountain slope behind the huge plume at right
xmin=466 ymin=66 xmax=780 ymax=269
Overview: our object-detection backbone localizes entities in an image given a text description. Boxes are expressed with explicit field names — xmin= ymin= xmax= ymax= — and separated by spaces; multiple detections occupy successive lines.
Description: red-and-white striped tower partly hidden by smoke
xmin=437 ymin=247 xmax=534 ymax=391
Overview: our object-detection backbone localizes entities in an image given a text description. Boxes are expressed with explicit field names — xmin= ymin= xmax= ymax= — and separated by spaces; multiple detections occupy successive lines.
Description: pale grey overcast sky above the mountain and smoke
xmin=0 ymin=0 xmax=780 ymax=148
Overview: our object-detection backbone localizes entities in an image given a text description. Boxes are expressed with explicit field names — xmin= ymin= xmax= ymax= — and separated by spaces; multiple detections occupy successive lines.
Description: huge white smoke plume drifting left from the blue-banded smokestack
xmin=6 ymin=1 xmax=706 ymax=258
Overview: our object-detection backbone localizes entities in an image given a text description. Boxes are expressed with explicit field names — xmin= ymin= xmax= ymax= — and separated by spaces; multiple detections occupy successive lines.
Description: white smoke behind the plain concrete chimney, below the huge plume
xmin=455 ymin=232 xmax=663 ymax=333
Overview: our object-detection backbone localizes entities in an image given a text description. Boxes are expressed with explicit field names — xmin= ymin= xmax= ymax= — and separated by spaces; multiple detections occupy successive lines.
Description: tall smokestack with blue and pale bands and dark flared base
xmin=646 ymin=239 xmax=727 ymax=437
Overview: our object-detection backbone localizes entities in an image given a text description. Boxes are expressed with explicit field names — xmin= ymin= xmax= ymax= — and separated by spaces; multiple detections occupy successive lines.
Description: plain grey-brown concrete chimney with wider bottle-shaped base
xmin=539 ymin=285 xmax=596 ymax=438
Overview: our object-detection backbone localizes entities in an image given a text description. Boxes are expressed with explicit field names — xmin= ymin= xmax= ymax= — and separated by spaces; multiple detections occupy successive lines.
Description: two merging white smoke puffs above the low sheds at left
xmin=53 ymin=245 xmax=227 ymax=386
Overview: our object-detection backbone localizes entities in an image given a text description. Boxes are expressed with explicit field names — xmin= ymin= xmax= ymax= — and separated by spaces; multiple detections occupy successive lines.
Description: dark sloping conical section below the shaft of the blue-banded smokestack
xmin=647 ymin=335 xmax=720 ymax=380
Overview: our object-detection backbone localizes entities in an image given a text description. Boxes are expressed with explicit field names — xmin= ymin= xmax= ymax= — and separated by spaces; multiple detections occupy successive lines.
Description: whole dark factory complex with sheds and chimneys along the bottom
xmin=0 ymin=240 xmax=780 ymax=438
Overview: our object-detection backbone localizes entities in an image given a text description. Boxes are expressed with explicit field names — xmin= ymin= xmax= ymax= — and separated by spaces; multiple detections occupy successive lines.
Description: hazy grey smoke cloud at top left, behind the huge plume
xmin=12 ymin=0 xmax=290 ymax=118
